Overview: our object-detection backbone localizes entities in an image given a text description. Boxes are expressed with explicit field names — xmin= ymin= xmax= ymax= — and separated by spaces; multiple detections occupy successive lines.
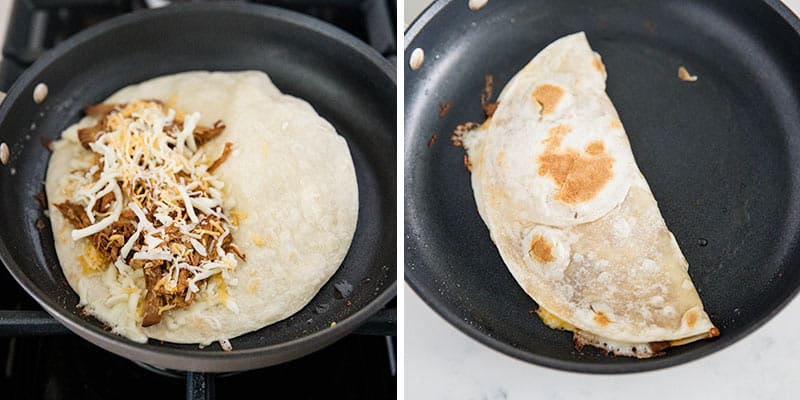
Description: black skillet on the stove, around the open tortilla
xmin=0 ymin=4 xmax=397 ymax=372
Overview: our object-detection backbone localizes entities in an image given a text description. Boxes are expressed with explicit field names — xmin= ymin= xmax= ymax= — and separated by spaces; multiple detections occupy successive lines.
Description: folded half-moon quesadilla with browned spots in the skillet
xmin=463 ymin=33 xmax=719 ymax=358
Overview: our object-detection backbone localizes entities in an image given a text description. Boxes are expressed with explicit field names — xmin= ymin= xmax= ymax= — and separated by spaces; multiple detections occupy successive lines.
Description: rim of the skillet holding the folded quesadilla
xmin=403 ymin=0 xmax=800 ymax=374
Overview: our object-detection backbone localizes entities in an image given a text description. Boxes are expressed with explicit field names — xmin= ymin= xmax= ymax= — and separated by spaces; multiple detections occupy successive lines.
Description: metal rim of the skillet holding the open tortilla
xmin=0 ymin=3 xmax=397 ymax=372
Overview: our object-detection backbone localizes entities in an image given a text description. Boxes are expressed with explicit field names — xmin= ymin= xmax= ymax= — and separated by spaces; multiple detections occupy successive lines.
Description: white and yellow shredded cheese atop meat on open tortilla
xmin=61 ymin=101 xmax=246 ymax=324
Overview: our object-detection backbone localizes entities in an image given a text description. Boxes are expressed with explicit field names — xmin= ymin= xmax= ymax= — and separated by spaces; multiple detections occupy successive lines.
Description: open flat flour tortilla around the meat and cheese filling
xmin=46 ymin=71 xmax=358 ymax=344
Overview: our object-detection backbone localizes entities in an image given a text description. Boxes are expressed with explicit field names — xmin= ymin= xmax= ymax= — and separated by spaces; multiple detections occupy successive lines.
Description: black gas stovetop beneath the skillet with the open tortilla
xmin=0 ymin=0 xmax=397 ymax=400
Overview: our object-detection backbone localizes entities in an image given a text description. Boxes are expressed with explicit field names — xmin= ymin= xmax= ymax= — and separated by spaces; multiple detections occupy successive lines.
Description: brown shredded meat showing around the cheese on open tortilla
xmin=54 ymin=100 xmax=245 ymax=327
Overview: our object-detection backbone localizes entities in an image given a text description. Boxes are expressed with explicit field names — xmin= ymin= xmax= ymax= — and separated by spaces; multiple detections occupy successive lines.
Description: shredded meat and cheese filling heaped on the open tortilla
xmin=55 ymin=100 xmax=245 ymax=327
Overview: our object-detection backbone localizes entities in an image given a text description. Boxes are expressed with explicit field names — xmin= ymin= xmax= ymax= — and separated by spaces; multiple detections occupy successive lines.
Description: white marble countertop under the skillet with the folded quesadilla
xmin=404 ymin=0 xmax=800 ymax=400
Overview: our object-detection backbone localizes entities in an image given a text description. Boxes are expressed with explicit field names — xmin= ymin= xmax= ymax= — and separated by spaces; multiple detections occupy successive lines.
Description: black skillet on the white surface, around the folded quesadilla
xmin=405 ymin=0 xmax=800 ymax=373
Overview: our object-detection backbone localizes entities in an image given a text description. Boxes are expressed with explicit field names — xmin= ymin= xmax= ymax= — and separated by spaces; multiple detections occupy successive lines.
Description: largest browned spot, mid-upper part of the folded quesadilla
xmin=539 ymin=139 xmax=614 ymax=204
